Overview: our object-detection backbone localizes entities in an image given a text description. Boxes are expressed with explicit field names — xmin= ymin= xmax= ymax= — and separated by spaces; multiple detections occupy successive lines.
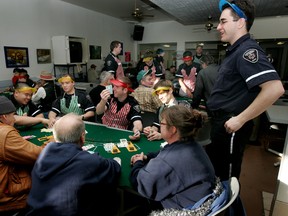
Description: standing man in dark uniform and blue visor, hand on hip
xmin=206 ymin=0 xmax=284 ymax=180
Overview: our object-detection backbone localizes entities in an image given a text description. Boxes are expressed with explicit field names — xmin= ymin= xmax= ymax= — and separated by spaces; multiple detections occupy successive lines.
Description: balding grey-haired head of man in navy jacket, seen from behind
xmin=53 ymin=113 xmax=85 ymax=143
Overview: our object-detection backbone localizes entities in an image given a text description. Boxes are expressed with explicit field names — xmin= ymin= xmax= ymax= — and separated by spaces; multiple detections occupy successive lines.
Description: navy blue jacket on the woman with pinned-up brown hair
xmin=130 ymin=141 xmax=215 ymax=209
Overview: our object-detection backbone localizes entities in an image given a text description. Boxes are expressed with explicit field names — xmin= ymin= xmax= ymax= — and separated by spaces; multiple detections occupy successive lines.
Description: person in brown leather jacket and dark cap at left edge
xmin=0 ymin=96 xmax=42 ymax=216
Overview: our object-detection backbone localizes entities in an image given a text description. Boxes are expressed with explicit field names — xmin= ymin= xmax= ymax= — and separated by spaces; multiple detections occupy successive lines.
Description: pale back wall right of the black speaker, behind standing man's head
xmin=140 ymin=16 xmax=288 ymax=45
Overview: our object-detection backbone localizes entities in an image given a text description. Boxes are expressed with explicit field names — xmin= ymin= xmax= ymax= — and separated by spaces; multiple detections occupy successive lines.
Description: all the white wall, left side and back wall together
xmin=0 ymin=0 xmax=288 ymax=80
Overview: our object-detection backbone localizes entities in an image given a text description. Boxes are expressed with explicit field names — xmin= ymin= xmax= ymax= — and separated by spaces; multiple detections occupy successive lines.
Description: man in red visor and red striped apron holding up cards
xmin=96 ymin=77 xmax=142 ymax=140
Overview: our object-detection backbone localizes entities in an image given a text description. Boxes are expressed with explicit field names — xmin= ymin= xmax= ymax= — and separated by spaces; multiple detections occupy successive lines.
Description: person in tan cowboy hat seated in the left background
xmin=32 ymin=71 xmax=60 ymax=116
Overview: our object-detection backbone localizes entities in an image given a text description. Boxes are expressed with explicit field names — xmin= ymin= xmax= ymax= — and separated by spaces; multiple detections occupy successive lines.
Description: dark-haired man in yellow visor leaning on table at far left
xmin=10 ymin=83 xmax=48 ymax=126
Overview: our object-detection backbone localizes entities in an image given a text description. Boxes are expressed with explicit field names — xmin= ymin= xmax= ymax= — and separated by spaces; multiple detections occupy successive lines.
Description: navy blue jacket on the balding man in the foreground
xmin=28 ymin=143 xmax=121 ymax=216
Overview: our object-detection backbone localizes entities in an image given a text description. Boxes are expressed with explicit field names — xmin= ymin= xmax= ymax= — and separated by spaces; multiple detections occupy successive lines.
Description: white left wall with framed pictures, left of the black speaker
xmin=0 ymin=0 xmax=135 ymax=80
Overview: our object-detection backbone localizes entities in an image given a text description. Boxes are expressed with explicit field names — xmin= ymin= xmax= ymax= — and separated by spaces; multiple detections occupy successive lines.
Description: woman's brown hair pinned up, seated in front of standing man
xmin=161 ymin=105 xmax=204 ymax=140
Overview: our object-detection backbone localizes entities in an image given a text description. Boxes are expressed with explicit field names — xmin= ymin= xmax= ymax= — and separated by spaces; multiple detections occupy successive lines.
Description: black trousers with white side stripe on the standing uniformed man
xmin=206 ymin=112 xmax=253 ymax=181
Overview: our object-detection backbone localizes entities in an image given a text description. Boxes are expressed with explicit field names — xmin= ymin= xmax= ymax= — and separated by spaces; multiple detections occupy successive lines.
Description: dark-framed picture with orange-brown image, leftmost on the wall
xmin=4 ymin=46 xmax=29 ymax=68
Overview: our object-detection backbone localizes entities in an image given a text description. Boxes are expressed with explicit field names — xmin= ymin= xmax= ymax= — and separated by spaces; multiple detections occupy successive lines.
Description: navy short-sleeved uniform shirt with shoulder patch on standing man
xmin=207 ymin=34 xmax=280 ymax=115
